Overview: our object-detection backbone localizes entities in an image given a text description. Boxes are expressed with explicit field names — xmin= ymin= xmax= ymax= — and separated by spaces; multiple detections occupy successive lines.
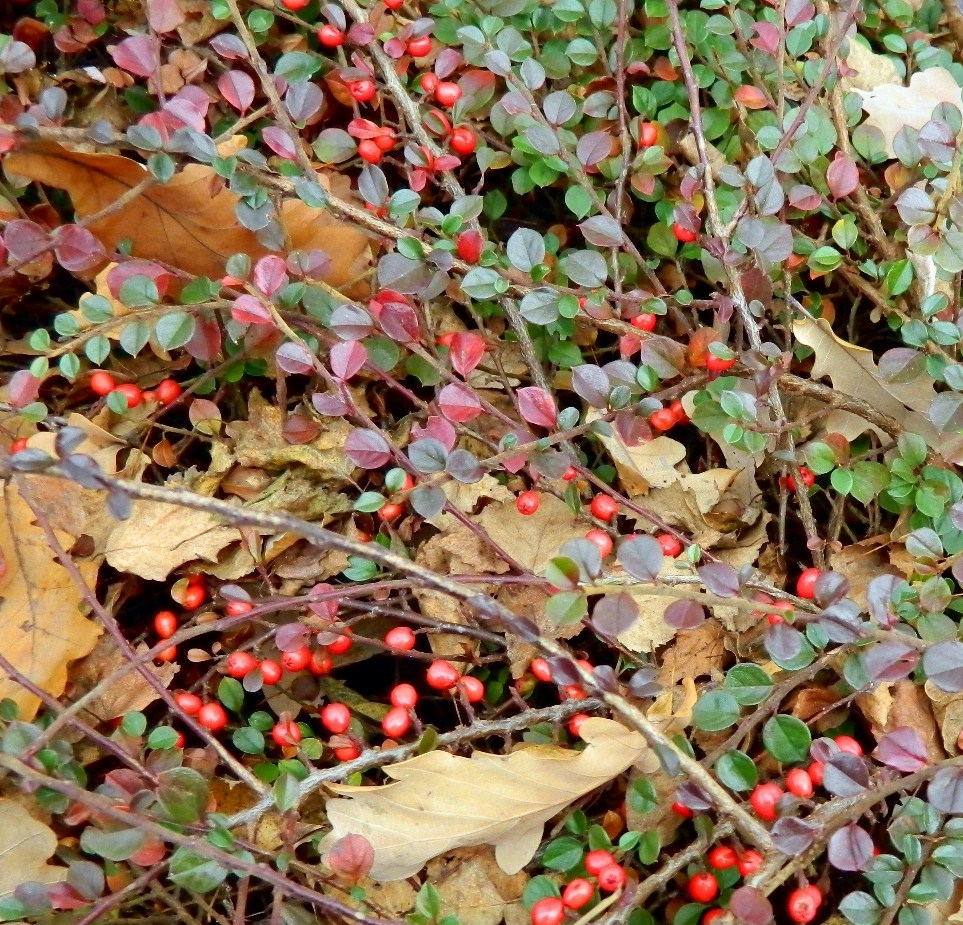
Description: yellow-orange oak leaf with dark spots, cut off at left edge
xmin=0 ymin=485 xmax=102 ymax=719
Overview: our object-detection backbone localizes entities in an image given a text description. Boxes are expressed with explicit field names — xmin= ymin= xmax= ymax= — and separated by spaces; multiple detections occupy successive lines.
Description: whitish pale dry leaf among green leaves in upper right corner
xmin=854 ymin=67 xmax=963 ymax=157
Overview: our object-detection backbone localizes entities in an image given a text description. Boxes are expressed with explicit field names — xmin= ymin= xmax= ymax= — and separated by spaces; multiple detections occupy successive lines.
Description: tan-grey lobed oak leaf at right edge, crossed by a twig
xmin=793 ymin=316 xmax=961 ymax=459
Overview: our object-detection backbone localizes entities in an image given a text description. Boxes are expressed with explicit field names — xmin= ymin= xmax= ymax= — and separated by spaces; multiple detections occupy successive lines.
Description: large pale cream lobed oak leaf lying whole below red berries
xmin=323 ymin=717 xmax=658 ymax=880
